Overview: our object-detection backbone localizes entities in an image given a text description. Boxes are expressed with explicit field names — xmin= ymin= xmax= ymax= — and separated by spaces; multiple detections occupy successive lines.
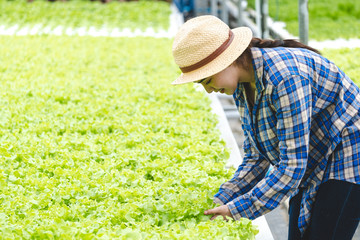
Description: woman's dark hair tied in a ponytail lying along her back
xmin=235 ymin=38 xmax=321 ymax=66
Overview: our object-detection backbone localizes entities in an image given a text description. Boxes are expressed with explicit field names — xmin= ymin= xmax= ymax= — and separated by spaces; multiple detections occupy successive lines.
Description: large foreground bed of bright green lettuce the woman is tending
xmin=0 ymin=36 xmax=257 ymax=239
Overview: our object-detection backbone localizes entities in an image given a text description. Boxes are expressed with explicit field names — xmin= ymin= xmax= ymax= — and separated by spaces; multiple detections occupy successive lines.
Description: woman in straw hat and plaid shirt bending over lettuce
xmin=172 ymin=16 xmax=360 ymax=240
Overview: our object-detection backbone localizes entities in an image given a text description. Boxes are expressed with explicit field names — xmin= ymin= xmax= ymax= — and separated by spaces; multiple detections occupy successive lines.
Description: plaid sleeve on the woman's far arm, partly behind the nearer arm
xmin=214 ymin=124 xmax=270 ymax=205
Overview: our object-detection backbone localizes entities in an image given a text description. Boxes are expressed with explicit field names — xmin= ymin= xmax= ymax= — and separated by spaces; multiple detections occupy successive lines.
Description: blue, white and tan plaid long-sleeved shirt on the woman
xmin=214 ymin=48 xmax=360 ymax=233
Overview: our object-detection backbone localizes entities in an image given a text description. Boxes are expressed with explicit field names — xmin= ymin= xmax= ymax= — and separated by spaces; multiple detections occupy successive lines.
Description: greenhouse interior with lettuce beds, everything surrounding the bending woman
xmin=0 ymin=0 xmax=360 ymax=240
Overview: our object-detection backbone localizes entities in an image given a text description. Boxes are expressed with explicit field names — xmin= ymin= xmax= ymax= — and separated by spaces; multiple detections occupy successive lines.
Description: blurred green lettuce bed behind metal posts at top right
xmin=248 ymin=0 xmax=360 ymax=41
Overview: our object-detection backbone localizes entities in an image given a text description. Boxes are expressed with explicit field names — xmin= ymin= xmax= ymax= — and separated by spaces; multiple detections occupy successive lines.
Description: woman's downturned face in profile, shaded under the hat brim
xmin=196 ymin=64 xmax=251 ymax=95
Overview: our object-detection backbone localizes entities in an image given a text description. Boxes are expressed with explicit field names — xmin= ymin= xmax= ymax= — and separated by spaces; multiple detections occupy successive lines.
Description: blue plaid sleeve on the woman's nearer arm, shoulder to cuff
xmin=227 ymin=76 xmax=312 ymax=220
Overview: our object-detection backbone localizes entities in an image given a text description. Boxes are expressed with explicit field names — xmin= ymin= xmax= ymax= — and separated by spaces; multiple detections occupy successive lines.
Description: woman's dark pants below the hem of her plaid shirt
xmin=288 ymin=180 xmax=360 ymax=240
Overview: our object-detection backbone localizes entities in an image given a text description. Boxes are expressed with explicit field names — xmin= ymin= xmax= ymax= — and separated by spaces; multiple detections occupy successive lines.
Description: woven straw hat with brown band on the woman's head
xmin=172 ymin=15 xmax=252 ymax=84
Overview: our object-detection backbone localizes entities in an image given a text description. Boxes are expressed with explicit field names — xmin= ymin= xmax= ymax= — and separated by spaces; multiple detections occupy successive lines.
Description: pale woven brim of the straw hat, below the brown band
xmin=172 ymin=27 xmax=252 ymax=85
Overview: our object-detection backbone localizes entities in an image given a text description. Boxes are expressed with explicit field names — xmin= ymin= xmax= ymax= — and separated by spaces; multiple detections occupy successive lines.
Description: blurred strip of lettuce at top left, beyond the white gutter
xmin=0 ymin=0 xmax=170 ymax=30
